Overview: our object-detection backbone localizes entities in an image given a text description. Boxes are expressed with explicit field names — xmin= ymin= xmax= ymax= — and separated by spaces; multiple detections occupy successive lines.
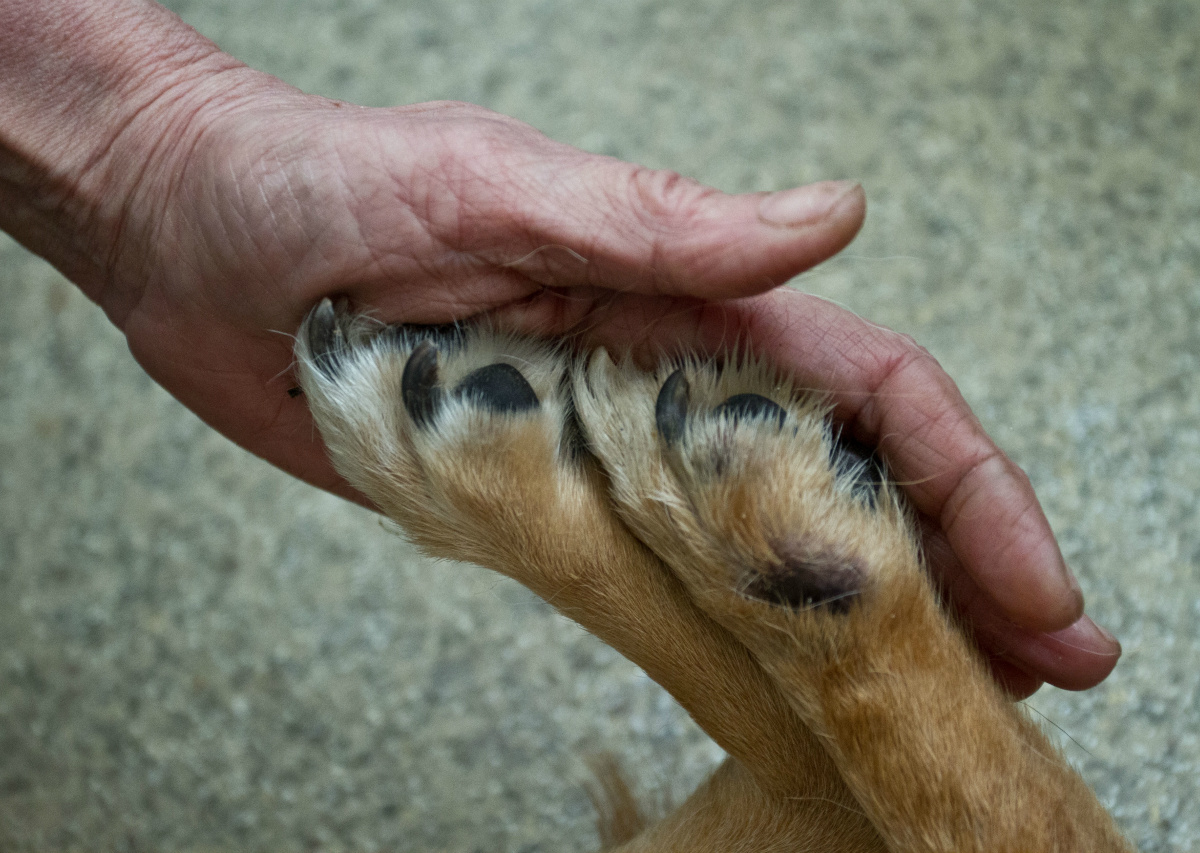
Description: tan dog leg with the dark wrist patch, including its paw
xmin=575 ymin=353 xmax=1129 ymax=853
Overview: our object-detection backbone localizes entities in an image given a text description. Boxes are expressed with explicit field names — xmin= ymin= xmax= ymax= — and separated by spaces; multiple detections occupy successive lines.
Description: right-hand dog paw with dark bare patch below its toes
xmin=575 ymin=354 xmax=923 ymax=647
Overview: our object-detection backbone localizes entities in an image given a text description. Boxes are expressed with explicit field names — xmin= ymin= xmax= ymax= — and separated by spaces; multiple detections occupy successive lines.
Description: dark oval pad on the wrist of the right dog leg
xmin=742 ymin=553 xmax=864 ymax=614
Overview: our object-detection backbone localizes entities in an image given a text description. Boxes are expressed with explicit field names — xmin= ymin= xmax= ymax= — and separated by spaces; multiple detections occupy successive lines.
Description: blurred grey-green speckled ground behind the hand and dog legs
xmin=0 ymin=0 xmax=1200 ymax=851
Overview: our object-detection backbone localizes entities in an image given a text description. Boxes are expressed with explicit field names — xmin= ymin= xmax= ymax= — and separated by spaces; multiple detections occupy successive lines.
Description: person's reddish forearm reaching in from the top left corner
xmin=0 ymin=0 xmax=243 ymax=316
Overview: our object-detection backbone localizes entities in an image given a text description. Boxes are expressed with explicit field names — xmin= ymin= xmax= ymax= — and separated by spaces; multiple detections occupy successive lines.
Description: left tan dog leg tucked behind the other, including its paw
xmin=296 ymin=300 xmax=882 ymax=852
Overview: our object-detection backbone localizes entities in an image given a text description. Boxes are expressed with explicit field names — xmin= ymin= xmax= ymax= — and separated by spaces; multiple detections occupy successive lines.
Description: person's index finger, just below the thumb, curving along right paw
xmin=542 ymin=289 xmax=1082 ymax=632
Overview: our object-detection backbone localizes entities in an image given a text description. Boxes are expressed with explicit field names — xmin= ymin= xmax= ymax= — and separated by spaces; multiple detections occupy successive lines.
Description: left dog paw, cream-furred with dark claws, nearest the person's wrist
xmin=296 ymin=300 xmax=585 ymax=567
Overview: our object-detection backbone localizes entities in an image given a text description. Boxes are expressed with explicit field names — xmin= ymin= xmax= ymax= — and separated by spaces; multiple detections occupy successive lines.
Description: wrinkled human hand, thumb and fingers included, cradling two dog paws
xmin=0 ymin=0 xmax=1118 ymax=695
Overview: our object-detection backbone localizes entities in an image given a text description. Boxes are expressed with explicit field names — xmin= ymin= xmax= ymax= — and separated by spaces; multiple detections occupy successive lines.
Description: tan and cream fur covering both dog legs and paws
xmin=296 ymin=304 xmax=1128 ymax=853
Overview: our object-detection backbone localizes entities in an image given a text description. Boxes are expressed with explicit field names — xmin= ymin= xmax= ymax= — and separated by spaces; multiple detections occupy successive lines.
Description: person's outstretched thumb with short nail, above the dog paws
xmin=403 ymin=110 xmax=866 ymax=299
